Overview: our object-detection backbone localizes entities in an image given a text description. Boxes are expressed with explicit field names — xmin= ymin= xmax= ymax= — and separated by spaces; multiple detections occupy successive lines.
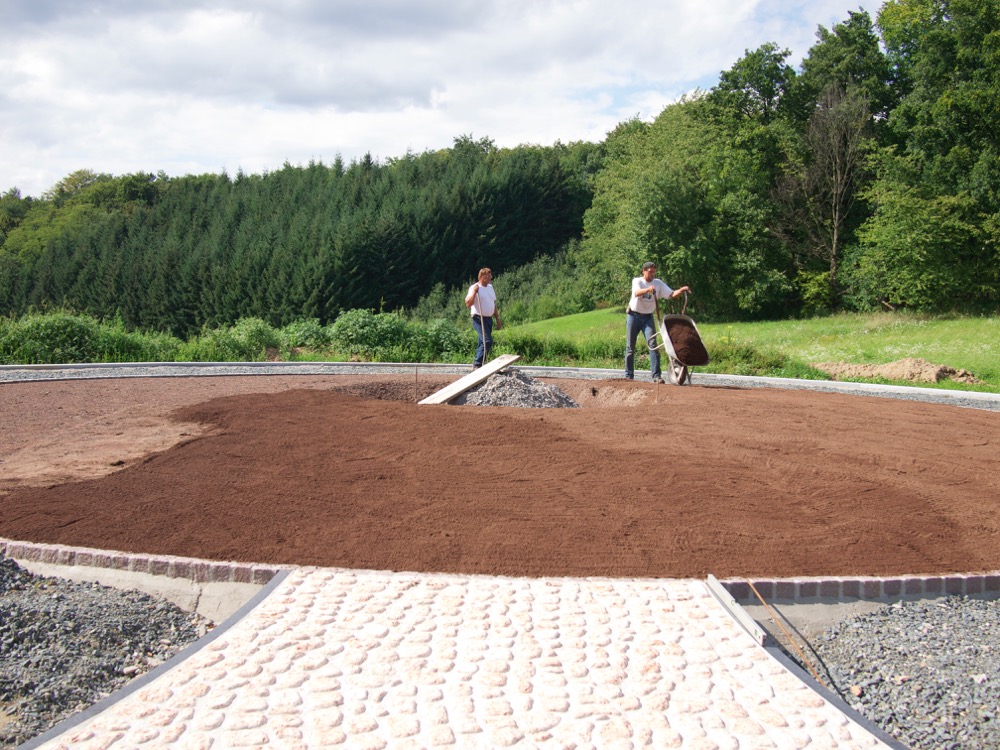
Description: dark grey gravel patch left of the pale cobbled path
xmin=0 ymin=555 xmax=210 ymax=747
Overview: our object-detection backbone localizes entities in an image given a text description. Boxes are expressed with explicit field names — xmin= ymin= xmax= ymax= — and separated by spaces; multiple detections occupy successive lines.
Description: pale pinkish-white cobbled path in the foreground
xmin=31 ymin=568 xmax=887 ymax=750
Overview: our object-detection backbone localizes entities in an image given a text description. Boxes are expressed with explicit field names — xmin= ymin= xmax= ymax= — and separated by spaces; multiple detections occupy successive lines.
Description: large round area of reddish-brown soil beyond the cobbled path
xmin=0 ymin=376 xmax=1000 ymax=577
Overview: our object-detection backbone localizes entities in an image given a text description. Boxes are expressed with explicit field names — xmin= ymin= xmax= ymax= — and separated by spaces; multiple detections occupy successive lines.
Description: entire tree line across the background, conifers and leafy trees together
xmin=0 ymin=0 xmax=1000 ymax=335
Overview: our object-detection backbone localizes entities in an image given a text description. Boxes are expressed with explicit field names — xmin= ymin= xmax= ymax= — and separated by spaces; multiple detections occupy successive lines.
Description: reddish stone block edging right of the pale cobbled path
xmin=720 ymin=571 xmax=1000 ymax=604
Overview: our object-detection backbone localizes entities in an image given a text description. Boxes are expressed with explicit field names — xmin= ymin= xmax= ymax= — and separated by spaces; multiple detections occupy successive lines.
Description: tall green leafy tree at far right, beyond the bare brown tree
xmin=854 ymin=0 xmax=1000 ymax=309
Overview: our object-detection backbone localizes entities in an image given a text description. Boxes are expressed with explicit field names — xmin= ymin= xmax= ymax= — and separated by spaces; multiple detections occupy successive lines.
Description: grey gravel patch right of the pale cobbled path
xmin=814 ymin=596 xmax=1000 ymax=750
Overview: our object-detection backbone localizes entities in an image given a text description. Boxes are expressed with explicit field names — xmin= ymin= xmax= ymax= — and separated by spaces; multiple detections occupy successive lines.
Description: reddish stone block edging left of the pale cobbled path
xmin=0 ymin=538 xmax=294 ymax=586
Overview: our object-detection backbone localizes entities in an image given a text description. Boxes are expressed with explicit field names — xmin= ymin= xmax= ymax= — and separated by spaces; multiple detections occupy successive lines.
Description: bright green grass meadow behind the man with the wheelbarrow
xmin=501 ymin=310 xmax=1000 ymax=392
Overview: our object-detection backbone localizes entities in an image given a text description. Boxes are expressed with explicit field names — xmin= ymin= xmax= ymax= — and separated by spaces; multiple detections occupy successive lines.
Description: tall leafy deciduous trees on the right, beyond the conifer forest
xmin=580 ymin=0 xmax=1000 ymax=319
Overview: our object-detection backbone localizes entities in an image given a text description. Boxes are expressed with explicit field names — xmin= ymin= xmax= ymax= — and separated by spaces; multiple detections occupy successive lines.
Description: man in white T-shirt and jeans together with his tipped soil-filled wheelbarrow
xmin=625 ymin=262 xmax=708 ymax=385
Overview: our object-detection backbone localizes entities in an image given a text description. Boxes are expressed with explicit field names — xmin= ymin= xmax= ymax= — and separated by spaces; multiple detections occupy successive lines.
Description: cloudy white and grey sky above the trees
xmin=0 ymin=0 xmax=881 ymax=196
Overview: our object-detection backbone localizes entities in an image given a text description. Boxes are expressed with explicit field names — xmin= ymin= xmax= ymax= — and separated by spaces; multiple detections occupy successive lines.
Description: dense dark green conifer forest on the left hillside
xmin=0 ymin=143 xmax=601 ymax=336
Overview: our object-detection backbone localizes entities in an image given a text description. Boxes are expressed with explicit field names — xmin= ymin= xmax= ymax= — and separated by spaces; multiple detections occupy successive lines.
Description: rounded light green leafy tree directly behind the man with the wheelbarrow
xmin=571 ymin=98 xmax=791 ymax=319
